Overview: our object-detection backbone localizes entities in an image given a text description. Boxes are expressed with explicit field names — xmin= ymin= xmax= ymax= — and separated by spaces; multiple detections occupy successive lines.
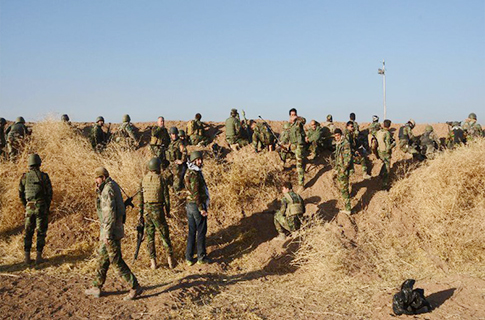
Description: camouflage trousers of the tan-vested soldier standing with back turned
xmin=145 ymin=203 xmax=173 ymax=259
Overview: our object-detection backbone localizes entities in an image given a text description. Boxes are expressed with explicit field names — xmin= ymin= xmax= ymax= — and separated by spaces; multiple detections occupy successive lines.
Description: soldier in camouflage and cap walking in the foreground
xmin=85 ymin=167 xmax=143 ymax=300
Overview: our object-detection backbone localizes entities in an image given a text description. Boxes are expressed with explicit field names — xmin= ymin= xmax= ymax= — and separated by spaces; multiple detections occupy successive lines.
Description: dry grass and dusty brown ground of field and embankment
xmin=0 ymin=121 xmax=485 ymax=319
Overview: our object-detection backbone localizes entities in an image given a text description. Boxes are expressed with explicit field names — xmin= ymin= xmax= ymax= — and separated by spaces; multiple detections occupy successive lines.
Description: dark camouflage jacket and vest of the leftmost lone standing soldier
xmin=19 ymin=167 xmax=52 ymax=211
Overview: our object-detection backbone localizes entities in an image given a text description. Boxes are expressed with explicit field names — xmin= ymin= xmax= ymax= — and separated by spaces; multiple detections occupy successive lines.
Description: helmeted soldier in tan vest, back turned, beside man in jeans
xmin=140 ymin=157 xmax=175 ymax=269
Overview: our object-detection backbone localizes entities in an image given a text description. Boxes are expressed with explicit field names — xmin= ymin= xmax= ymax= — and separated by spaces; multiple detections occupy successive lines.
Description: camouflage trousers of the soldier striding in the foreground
xmin=93 ymin=239 xmax=139 ymax=289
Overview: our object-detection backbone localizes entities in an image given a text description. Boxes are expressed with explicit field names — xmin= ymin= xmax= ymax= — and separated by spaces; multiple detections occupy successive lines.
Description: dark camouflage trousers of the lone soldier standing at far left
xmin=24 ymin=205 xmax=49 ymax=252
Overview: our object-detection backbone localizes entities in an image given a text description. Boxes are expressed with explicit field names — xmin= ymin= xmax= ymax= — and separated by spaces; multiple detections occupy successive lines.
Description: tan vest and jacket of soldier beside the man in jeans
xmin=140 ymin=171 xmax=170 ymax=213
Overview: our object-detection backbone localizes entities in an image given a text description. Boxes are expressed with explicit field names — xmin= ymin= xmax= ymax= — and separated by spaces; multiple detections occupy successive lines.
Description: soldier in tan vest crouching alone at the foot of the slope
xmin=274 ymin=181 xmax=305 ymax=240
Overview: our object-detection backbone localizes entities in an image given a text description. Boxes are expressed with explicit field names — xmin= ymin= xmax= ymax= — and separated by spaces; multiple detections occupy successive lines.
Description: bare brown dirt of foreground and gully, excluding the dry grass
xmin=0 ymin=122 xmax=485 ymax=320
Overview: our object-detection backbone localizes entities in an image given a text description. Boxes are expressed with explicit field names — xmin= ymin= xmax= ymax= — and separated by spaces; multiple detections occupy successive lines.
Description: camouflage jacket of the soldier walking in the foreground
xmin=96 ymin=177 xmax=126 ymax=241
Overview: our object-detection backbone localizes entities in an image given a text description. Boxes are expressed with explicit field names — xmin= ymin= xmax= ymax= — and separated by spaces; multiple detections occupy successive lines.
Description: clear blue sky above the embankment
xmin=0 ymin=0 xmax=485 ymax=124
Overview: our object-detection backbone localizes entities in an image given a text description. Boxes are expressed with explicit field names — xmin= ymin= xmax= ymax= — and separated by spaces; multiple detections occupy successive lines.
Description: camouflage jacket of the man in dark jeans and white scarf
xmin=185 ymin=164 xmax=209 ymax=210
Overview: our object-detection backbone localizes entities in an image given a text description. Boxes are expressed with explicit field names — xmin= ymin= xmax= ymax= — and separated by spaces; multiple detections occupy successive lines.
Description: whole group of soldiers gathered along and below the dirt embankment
xmin=0 ymin=108 xmax=483 ymax=299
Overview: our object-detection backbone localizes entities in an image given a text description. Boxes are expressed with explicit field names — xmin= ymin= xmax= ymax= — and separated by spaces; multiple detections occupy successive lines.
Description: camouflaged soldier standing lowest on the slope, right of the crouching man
xmin=334 ymin=128 xmax=353 ymax=215
